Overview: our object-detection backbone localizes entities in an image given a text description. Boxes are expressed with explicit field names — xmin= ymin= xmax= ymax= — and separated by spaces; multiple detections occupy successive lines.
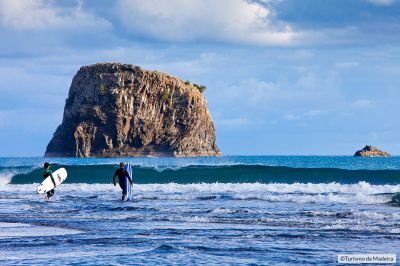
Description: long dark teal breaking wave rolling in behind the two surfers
xmin=4 ymin=165 xmax=400 ymax=185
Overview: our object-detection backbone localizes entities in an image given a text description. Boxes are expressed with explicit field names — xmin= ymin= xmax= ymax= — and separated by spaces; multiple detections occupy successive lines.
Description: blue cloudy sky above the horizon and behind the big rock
xmin=0 ymin=0 xmax=400 ymax=156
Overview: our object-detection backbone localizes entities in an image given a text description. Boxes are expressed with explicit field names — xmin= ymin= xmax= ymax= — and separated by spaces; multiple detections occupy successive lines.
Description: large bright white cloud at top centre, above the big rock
xmin=116 ymin=0 xmax=302 ymax=45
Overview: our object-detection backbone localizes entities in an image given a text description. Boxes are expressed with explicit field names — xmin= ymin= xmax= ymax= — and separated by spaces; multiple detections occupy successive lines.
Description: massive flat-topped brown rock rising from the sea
xmin=45 ymin=63 xmax=220 ymax=157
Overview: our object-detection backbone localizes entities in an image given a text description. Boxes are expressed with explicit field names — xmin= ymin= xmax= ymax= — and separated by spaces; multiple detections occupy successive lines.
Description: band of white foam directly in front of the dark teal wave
xmin=0 ymin=182 xmax=400 ymax=204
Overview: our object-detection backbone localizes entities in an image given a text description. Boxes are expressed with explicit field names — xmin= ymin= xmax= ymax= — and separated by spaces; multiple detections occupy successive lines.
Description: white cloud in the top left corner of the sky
xmin=0 ymin=0 xmax=111 ymax=30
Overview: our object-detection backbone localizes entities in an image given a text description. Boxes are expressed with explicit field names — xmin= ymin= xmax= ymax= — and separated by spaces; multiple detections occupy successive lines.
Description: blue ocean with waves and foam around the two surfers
xmin=0 ymin=156 xmax=400 ymax=265
